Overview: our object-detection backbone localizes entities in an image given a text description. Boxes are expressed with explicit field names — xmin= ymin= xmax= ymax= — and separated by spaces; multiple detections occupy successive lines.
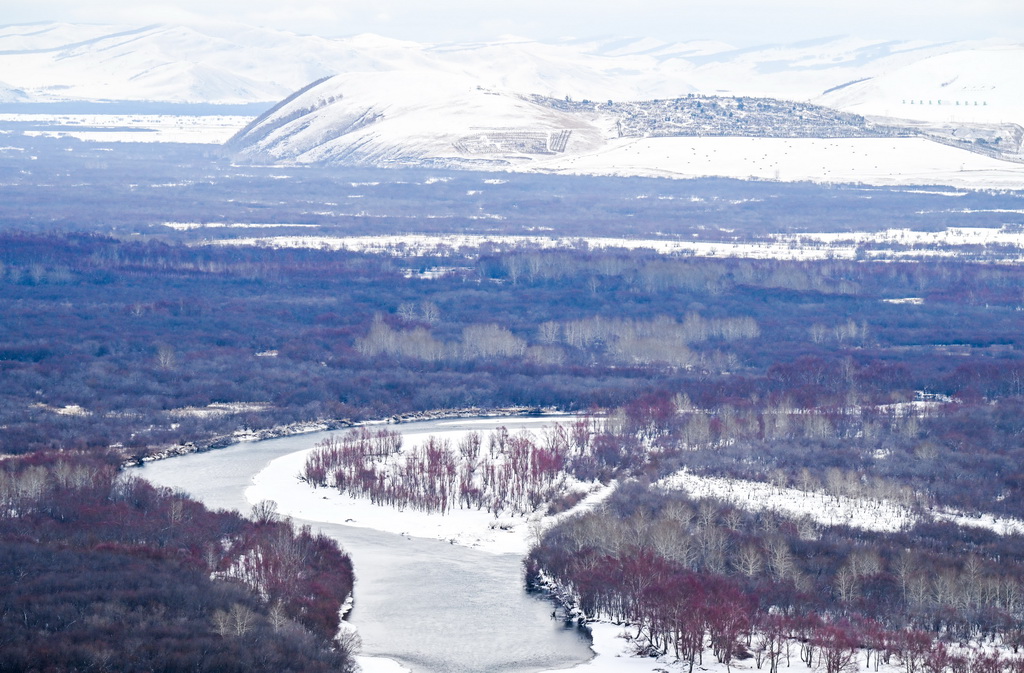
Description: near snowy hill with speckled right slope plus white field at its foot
xmin=225 ymin=66 xmax=1024 ymax=188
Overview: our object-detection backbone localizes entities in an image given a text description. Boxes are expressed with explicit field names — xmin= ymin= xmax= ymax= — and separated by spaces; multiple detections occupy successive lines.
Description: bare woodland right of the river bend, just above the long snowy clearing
xmin=607 ymin=385 xmax=1024 ymax=517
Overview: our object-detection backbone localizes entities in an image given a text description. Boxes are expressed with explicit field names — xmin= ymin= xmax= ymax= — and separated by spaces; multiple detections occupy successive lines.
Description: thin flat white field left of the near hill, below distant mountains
xmin=0 ymin=113 xmax=252 ymax=144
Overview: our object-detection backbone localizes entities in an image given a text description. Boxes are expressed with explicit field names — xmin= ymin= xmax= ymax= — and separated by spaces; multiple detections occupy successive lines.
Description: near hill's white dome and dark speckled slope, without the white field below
xmin=227 ymin=70 xmax=888 ymax=167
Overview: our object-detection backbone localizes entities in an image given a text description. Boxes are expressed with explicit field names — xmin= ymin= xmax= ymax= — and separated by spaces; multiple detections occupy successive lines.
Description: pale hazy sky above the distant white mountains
xmin=0 ymin=0 xmax=1024 ymax=46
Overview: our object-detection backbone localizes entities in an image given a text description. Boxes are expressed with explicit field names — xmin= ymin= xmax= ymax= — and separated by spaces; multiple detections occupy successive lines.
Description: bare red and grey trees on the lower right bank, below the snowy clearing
xmin=526 ymin=481 xmax=1024 ymax=673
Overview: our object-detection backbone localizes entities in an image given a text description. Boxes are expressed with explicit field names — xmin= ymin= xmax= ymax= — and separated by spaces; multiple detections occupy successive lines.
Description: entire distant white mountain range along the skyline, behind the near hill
xmin=0 ymin=24 xmax=1024 ymax=128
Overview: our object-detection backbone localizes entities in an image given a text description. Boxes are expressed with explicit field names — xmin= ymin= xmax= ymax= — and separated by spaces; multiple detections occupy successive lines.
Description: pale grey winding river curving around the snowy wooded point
xmin=133 ymin=417 xmax=592 ymax=673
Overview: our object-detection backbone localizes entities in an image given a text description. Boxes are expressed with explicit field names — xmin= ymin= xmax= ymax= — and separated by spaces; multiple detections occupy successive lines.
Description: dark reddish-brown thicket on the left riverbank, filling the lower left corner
xmin=0 ymin=453 xmax=354 ymax=673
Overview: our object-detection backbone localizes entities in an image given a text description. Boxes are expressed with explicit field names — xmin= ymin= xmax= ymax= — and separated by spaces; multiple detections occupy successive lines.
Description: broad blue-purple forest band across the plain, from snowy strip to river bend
xmin=6 ymin=229 xmax=1024 ymax=455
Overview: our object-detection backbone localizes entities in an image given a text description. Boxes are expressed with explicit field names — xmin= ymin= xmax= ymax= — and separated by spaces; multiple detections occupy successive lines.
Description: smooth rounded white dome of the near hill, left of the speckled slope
xmin=228 ymin=72 xmax=610 ymax=166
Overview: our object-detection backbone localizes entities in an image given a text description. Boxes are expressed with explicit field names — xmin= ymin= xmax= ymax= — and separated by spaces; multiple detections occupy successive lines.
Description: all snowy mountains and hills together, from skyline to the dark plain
xmin=0 ymin=24 xmax=1024 ymax=187
